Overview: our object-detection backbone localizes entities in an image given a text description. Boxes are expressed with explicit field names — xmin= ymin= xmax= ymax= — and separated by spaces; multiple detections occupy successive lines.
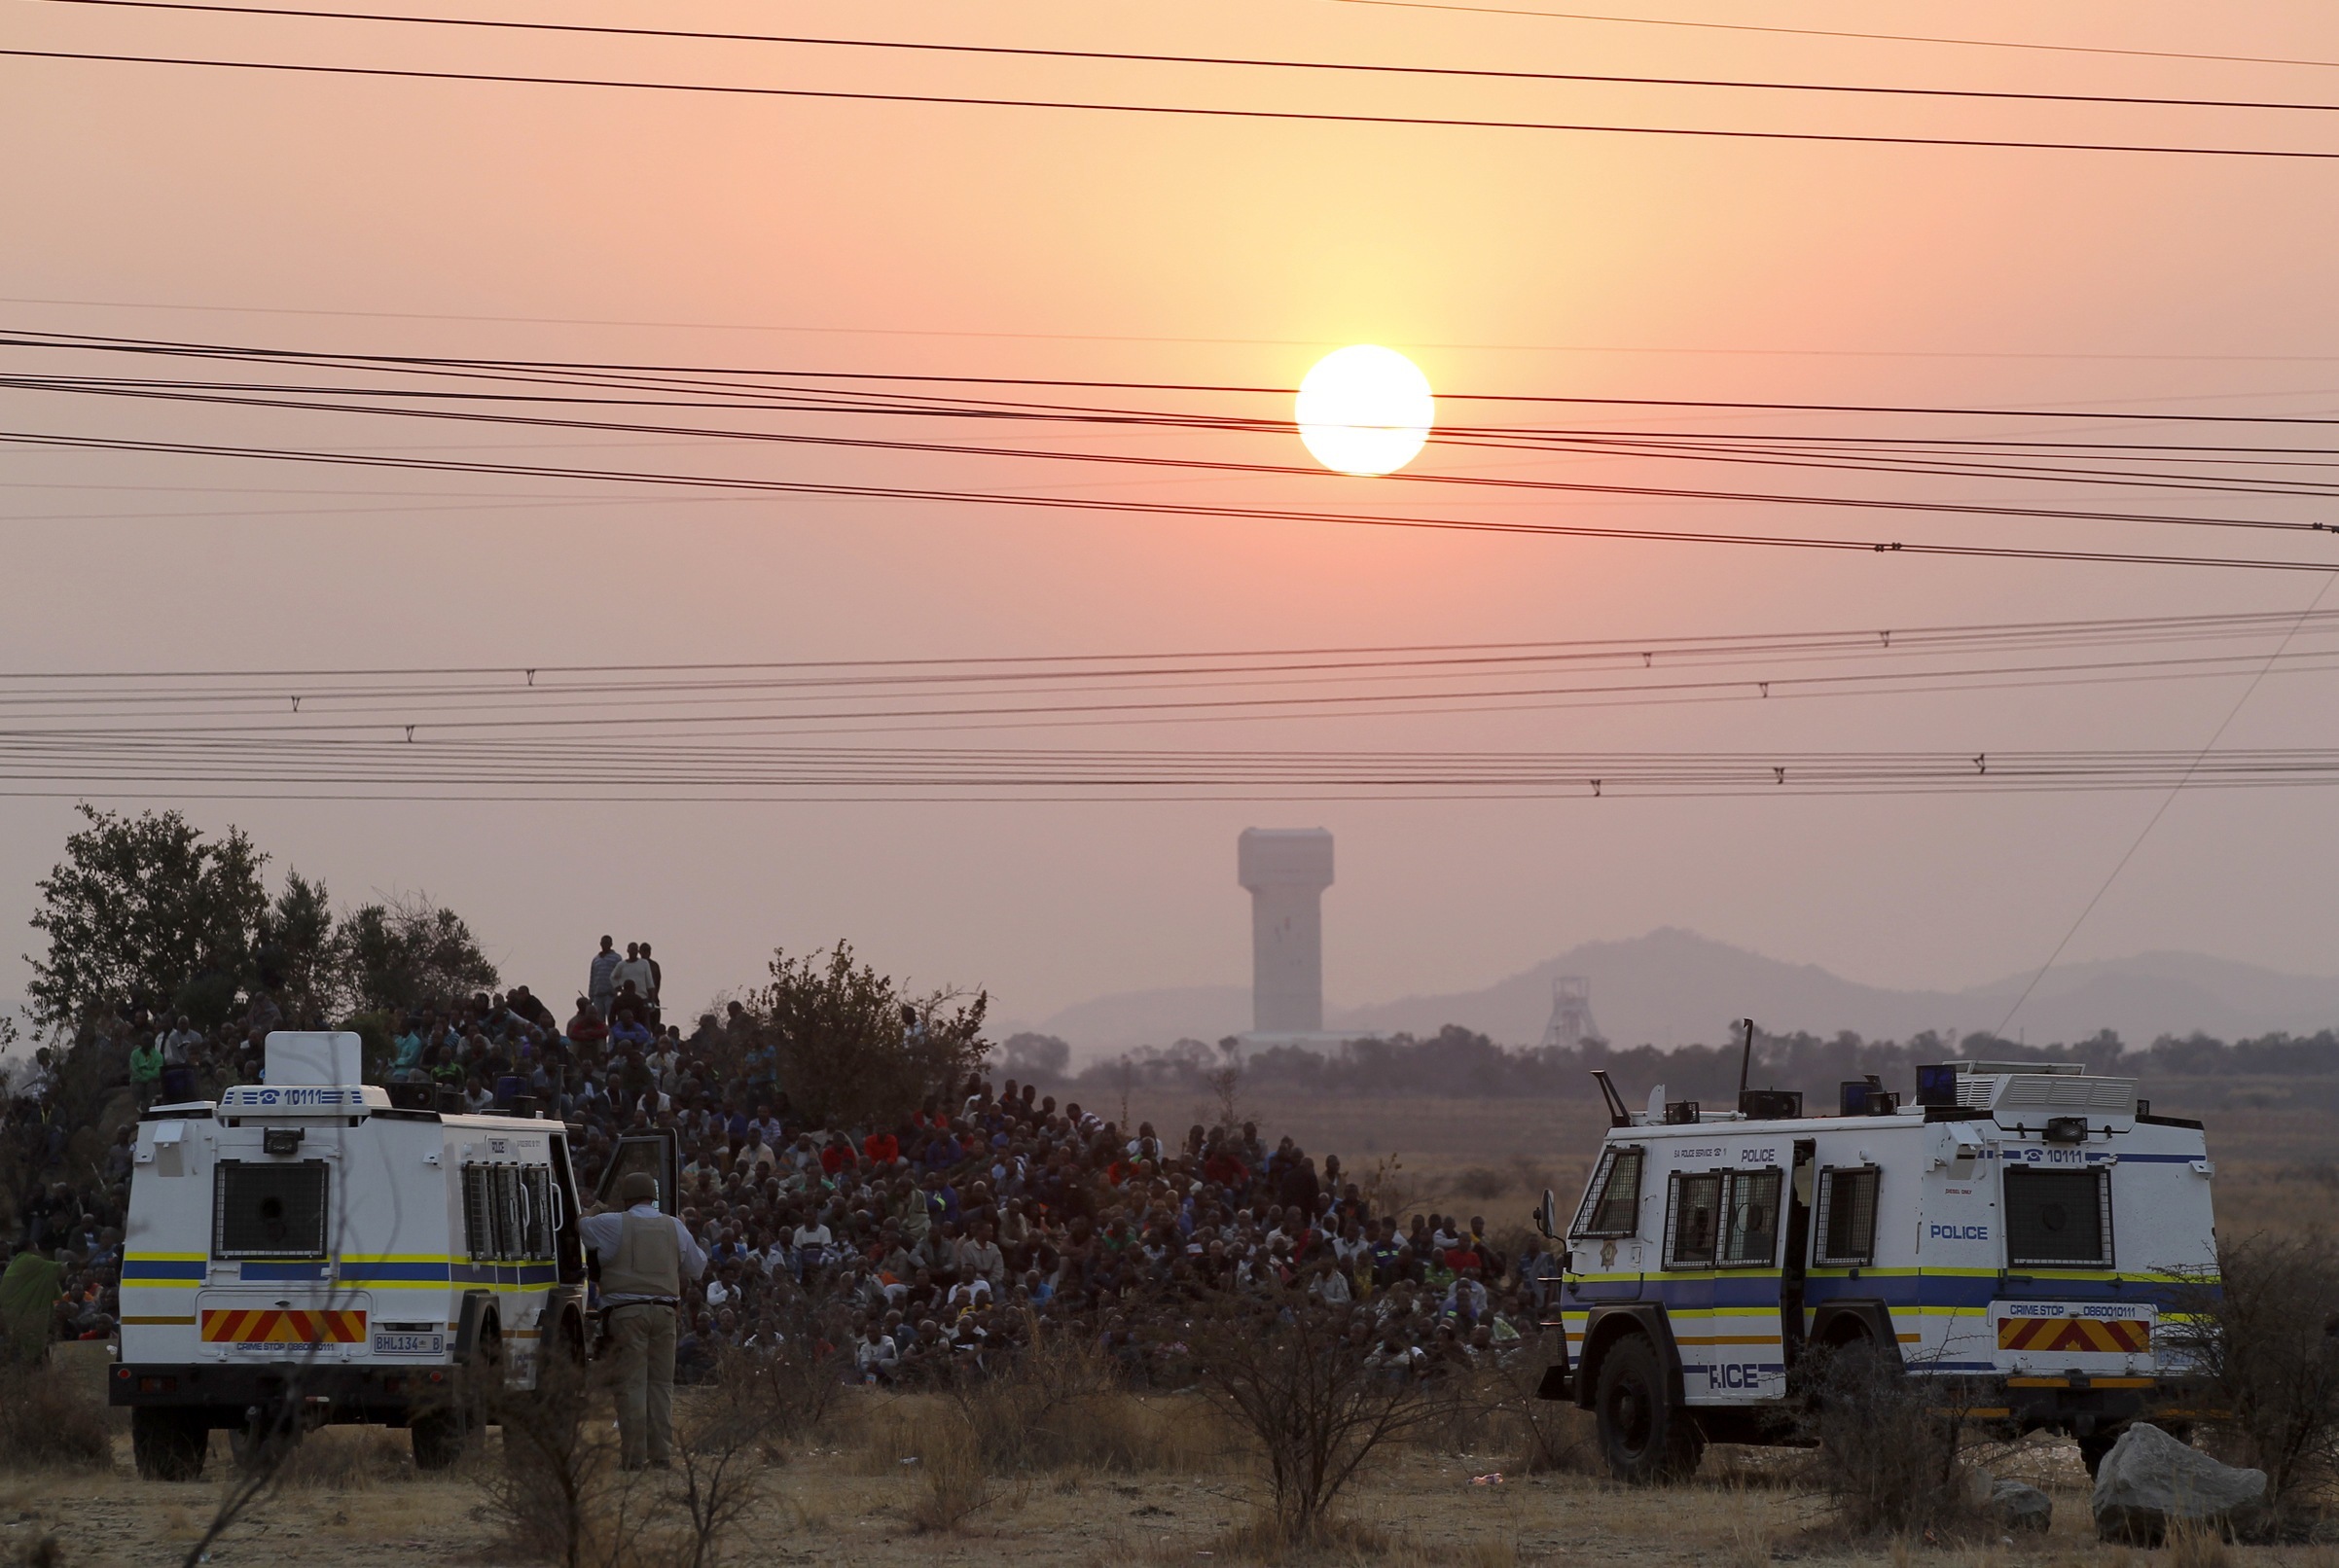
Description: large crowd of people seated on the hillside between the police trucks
xmin=0 ymin=937 xmax=1553 ymax=1386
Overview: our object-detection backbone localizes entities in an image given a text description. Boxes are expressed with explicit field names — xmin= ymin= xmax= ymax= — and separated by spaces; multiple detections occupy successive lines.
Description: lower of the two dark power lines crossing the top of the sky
xmin=14 ymin=49 xmax=2339 ymax=161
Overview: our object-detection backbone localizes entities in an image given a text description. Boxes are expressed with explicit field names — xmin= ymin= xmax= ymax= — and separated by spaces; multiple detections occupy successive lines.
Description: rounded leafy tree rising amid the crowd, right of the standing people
xmin=755 ymin=942 xmax=991 ymax=1124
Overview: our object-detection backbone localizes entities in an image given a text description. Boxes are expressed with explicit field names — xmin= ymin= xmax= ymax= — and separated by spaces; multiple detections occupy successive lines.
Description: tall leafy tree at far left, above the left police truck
xmin=25 ymin=803 xmax=267 ymax=1026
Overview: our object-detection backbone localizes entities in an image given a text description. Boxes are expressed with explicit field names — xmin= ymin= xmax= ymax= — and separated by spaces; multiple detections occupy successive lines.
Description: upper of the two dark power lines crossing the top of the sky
xmin=40 ymin=0 xmax=2339 ymax=115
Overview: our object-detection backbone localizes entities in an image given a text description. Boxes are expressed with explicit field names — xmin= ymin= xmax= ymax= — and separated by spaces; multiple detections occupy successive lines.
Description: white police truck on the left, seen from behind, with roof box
xmin=108 ymin=1033 xmax=650 ymax=1479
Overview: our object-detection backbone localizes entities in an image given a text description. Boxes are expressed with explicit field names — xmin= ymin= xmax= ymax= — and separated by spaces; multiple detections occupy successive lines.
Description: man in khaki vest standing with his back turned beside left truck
xmin=583 ymin=1171 xmax=706 ymax=1470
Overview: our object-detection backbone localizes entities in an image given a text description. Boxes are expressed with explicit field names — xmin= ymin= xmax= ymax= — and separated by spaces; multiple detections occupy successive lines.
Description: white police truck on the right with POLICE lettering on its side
xmin=1536 ymin=1061 xmax=2217 ymax=1481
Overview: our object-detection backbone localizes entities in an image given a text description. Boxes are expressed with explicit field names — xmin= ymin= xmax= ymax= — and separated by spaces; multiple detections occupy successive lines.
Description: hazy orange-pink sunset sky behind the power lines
xmin=0 ymin=0 xmax=2339 ymax=1042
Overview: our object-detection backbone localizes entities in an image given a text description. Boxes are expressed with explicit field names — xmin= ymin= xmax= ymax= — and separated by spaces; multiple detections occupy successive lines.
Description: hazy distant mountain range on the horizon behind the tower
xmin=1043 ymin=928 xmax=2339 ymax=1058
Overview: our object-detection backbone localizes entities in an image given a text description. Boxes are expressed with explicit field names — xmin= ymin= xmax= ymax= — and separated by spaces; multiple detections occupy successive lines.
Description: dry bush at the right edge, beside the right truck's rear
xmin=2161 ymin=1236 xmax=2339 ymax=1508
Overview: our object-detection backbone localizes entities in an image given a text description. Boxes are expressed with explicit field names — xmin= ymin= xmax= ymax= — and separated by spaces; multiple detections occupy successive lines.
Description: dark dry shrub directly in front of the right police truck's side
xmin=1796 ymin=1343 xmax=1988 ymax=1540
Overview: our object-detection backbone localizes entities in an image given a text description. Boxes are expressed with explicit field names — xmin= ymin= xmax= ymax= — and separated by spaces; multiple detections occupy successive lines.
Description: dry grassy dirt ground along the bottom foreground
xmin=0 ymin=1428 xmax=2339 ymax=1568
